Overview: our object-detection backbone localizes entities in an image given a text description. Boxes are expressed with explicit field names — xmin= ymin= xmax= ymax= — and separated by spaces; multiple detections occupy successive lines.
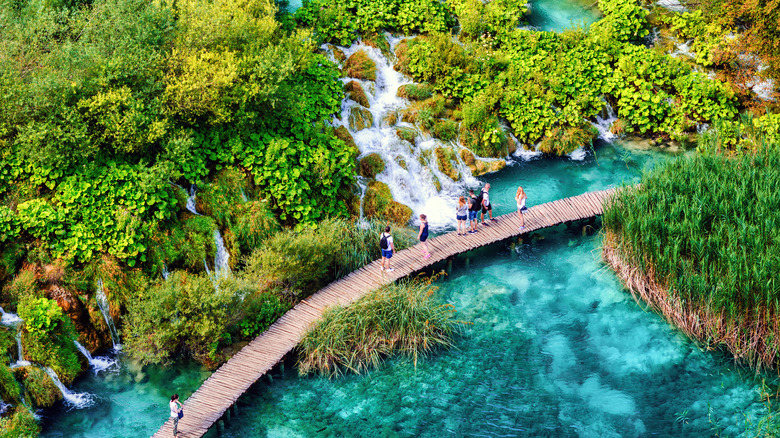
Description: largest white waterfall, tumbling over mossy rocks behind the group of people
xmin=330 ymin=37 xmax=479 ymax=229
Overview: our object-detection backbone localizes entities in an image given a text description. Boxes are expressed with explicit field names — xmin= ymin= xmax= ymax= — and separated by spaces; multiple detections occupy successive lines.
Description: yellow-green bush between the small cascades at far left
xmin=19 ymin=298 xmax=82 ymax=385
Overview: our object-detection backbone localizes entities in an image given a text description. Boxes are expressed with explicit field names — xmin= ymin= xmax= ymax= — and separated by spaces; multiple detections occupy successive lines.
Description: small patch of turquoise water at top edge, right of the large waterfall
xmin=526 ymin=0 xmax=601 ymax=32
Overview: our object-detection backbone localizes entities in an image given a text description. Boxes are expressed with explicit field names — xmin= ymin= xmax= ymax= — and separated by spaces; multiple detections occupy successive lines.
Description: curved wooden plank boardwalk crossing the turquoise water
xmin=153 ymin=189 xmax=615 ymax=438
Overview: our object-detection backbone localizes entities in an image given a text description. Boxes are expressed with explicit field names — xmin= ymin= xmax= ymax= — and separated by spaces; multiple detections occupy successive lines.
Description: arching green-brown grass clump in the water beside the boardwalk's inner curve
xmin=298 ymin=279 xmax=461 ymax=377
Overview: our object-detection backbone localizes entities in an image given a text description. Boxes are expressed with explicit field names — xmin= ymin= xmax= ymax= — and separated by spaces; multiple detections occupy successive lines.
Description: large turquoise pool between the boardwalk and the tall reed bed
xmin=215 ymin=227 xmax=761 ymax=438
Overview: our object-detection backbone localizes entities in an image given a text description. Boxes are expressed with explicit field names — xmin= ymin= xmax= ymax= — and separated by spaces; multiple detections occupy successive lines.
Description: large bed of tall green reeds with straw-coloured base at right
xmin=603 ymin=150 xmax=780 ymax=368
